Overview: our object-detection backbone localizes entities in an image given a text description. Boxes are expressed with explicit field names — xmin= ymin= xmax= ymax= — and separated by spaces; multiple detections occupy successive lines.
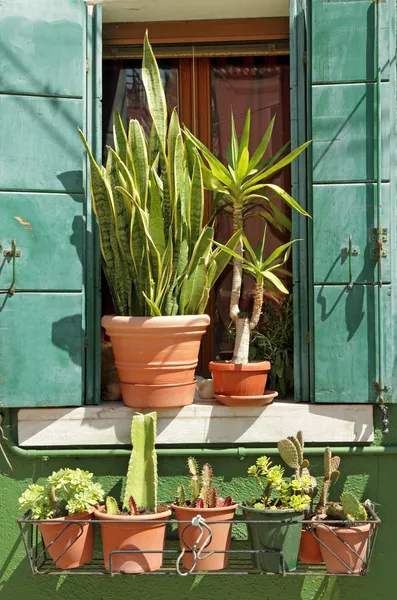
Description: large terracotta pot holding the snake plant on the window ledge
xmin=102 ymin=315 xmax=210 ymax=408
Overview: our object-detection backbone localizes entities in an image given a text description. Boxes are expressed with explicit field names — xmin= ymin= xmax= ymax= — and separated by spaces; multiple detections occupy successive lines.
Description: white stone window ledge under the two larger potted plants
xmin=18 ymin=400 xmax=374 ymax=447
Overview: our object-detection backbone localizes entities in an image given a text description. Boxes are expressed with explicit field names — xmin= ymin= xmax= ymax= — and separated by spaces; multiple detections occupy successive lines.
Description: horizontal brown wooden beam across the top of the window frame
xmin=103 ymin=17 xmax=289 ymax=46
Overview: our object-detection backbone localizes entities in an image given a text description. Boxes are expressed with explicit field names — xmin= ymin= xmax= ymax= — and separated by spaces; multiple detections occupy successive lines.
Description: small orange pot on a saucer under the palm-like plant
xmin=209 ymin=360 xmax=271 ymax=396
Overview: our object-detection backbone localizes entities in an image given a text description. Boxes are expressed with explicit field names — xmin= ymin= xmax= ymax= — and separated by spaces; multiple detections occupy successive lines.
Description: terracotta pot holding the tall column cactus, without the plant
xmin=95 ymin=510 xmax=171 ymax=573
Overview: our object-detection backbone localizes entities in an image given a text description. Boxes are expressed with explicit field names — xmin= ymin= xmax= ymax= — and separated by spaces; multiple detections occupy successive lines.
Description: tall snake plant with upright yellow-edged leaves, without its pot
xmin=80 ymin=33 xmax=239 ymax=316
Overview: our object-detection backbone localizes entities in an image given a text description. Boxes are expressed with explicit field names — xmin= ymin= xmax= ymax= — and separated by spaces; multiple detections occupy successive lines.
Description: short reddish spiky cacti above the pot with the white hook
xmin=176 ymin=456 xmax=233 ymax=508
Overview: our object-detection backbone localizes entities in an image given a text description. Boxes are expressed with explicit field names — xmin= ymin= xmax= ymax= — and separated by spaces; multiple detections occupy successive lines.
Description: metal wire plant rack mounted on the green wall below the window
xmin=17 ymin=506 xmax=381 ymax=577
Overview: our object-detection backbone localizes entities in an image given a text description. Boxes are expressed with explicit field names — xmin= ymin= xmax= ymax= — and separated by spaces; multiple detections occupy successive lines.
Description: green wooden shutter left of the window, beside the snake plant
xmin=0 ymin=0 xmax=100 ymax=407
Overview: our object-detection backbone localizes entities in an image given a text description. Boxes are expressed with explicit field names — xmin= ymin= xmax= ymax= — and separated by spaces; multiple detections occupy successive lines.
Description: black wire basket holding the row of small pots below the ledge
xmin=17 ymin=507 xmax=381 ymax=577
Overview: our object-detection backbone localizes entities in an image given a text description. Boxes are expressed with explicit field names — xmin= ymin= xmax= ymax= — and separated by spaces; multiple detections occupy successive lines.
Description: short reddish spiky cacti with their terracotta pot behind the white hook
xmin=172 ymin=457 xmax=237 ymax=571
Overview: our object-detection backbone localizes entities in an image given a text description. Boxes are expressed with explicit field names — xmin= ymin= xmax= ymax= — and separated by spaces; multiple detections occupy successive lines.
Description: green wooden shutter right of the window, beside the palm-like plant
xmin=291 ymin=0 xmax=397 ymax=403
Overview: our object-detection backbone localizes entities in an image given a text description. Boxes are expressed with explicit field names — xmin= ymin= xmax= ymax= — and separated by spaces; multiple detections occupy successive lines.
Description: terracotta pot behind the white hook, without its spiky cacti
xmin=172 ymin=504 xmax=238 ymax=571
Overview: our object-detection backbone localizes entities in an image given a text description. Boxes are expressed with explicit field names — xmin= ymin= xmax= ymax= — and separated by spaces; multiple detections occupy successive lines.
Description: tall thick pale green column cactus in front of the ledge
xmin=123 ymin=412 xmax=157 ymax=512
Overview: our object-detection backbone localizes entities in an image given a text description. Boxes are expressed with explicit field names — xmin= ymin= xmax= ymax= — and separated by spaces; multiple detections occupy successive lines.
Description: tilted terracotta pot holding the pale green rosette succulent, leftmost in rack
xmin=38 ymin=512 xmax=94 ymax=569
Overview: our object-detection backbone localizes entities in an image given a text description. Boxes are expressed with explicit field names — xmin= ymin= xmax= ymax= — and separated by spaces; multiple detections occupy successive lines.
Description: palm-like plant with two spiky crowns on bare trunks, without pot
xmin=184 ymin=111 xmax=310 ymax=364
